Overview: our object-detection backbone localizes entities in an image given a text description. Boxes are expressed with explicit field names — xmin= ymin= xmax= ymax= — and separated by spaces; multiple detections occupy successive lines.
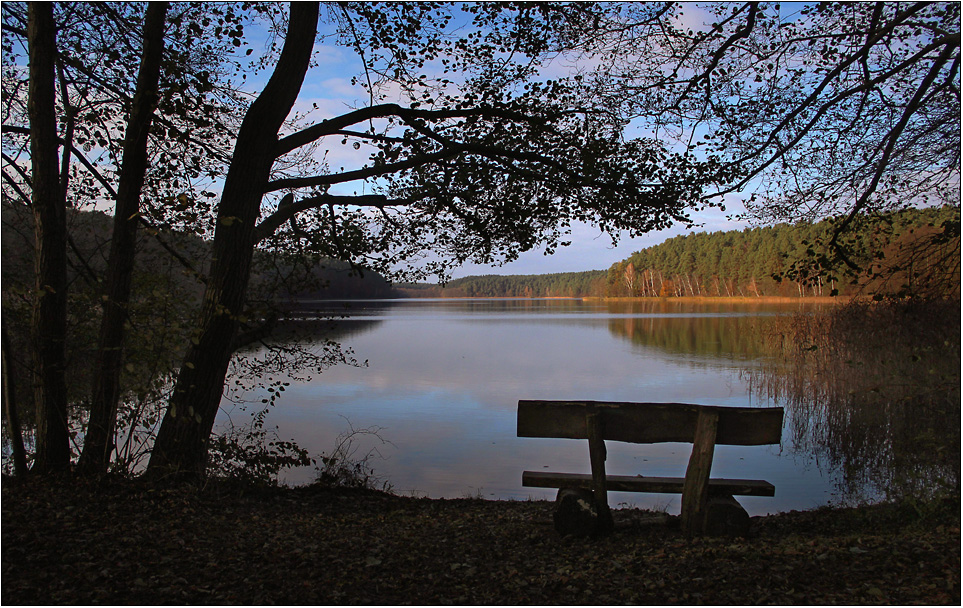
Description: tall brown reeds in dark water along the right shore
xmin=746 ymin=300 xmax=960 ymax=502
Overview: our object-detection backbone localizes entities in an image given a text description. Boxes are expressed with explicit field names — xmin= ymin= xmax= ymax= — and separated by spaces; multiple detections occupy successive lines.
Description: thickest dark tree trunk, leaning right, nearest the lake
xmin=147 ymin=2 xmax=318 ymax=478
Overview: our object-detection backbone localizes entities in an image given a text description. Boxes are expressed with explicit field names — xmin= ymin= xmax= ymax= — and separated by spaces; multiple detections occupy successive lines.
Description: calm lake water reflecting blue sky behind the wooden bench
xmin=220 ymin=299 xmax=860 ymax=515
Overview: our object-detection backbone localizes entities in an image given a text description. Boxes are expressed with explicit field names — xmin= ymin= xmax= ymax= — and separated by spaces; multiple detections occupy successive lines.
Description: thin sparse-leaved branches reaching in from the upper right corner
xmin=593 ymin=2 xmax=960 ymax=269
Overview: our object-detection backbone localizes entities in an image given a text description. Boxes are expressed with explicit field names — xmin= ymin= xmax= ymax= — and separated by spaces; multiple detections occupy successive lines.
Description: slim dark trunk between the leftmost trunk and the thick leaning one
xmin=80 ymin=2 xmax=167 ymax=473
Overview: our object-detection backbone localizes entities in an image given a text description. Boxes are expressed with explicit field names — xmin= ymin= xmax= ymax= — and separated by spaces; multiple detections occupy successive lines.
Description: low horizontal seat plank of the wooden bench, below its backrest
xmin=522 ymin=471 xmax=776 ymax=496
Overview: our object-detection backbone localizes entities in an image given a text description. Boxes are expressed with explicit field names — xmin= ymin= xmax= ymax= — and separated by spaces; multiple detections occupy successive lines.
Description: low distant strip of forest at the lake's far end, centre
xmin=397 ymin=270 xmax=606 ymax=298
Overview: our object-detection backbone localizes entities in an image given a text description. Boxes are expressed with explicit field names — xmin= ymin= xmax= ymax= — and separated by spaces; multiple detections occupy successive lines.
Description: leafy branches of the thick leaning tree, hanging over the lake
xmin=232 ymin=4 xmax=740 ymax=288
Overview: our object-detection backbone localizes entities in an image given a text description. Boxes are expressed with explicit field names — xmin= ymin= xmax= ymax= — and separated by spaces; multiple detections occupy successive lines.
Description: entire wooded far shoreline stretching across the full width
xmin=11 ymin=204 xmax=960 ymax=312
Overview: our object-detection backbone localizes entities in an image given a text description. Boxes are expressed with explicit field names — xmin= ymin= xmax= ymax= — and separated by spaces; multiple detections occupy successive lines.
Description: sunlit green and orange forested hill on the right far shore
xmin=606 ymin=206 xmax=960 ymax=297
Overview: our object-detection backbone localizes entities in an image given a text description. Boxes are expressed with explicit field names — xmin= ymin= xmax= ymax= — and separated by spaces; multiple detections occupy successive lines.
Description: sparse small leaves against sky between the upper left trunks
xmin=3 ymin=2 xmax=247 ymax=234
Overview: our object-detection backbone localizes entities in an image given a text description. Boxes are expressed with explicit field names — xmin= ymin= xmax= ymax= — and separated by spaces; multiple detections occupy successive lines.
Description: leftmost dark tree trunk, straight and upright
xmin=27 ymin=2 xmax=70 ymax=473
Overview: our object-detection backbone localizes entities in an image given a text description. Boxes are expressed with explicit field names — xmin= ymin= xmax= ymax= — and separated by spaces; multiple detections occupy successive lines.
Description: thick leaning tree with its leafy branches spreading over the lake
xmin=148 ymin=3 xmax=732 ymax=477
